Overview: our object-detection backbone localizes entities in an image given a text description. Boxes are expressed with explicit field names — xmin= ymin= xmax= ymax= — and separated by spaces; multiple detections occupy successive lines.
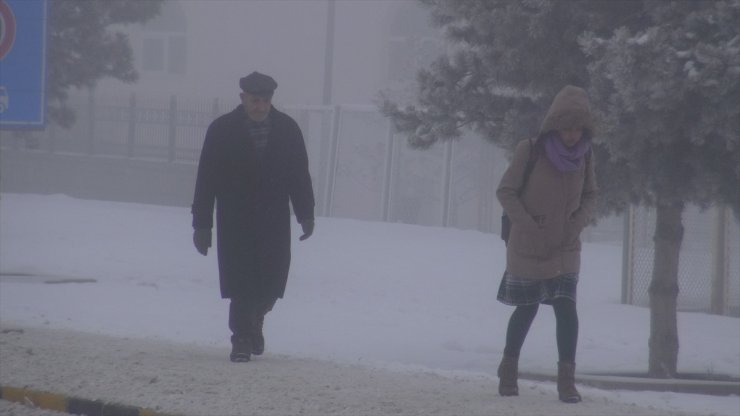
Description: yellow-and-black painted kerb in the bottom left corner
xmin=0 ymin=386 xmax=175 ymax=416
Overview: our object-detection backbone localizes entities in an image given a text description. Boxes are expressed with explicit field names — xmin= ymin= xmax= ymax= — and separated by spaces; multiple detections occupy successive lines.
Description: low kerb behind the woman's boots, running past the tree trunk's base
xmin=519 ymin=372 xmax=740 ymax=396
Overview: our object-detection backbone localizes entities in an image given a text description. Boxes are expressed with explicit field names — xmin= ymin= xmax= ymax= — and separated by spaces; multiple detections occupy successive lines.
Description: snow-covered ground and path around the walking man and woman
xmin=0 ymin=194 xmax=740 ymax=416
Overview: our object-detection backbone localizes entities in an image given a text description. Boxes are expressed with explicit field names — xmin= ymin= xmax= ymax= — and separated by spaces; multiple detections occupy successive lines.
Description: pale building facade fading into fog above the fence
xmin=101 ymin=0 xmax=430 ymax=105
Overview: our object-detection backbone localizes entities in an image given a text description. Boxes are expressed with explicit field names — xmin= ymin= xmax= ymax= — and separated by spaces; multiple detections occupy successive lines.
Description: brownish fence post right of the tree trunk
xmin=710 ymin=204 xmax=728 ymax=315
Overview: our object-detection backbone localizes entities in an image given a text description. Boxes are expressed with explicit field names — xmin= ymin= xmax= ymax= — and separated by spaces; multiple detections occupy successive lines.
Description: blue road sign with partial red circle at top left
xmin=0 ymin=0 xmax=47 ymax=128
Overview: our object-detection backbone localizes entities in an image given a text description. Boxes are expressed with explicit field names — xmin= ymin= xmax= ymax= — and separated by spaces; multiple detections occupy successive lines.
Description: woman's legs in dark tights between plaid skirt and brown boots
xmin=504 ymin=298 xmax=578 ymax=363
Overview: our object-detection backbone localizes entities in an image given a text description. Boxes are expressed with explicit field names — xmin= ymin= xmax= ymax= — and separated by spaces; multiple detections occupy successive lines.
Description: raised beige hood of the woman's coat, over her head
xmin=540 ymin=85 xmax=594 ymax=137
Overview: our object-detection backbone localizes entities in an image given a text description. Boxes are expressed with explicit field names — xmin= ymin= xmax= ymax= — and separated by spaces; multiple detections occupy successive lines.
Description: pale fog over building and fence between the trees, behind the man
xmin=3 ymin=0 xmax=532 ymax=236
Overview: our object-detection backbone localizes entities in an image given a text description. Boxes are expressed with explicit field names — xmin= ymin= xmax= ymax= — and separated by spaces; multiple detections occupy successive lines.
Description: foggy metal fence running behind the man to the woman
xmin=2 ymin=89 xmax=506 ymax=232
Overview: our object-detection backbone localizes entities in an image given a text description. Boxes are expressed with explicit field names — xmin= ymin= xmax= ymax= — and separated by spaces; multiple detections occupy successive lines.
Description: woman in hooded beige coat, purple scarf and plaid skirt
xmin=496 ymin=86 xmax=597 ymax=403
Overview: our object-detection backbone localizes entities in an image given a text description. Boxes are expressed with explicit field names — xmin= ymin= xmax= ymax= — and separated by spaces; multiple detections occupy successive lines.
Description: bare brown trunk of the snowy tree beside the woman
xmin=648 ymin=201 xmax=684 ymax=378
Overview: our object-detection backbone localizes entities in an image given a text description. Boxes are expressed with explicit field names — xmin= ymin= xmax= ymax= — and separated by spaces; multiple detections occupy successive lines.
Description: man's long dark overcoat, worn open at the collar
xmin=192 ymin=105 xmax=314 ymax=298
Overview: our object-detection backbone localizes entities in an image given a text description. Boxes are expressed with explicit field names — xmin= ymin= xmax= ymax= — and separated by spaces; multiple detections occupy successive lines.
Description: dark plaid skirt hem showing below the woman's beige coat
xmin=496 ymin=272 xmax=578 ymax=306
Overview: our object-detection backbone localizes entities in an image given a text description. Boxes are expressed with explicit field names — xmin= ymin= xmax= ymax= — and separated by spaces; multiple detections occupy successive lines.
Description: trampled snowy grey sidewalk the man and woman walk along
xmin=0 ymin=322 xmax=704 ymax=416
